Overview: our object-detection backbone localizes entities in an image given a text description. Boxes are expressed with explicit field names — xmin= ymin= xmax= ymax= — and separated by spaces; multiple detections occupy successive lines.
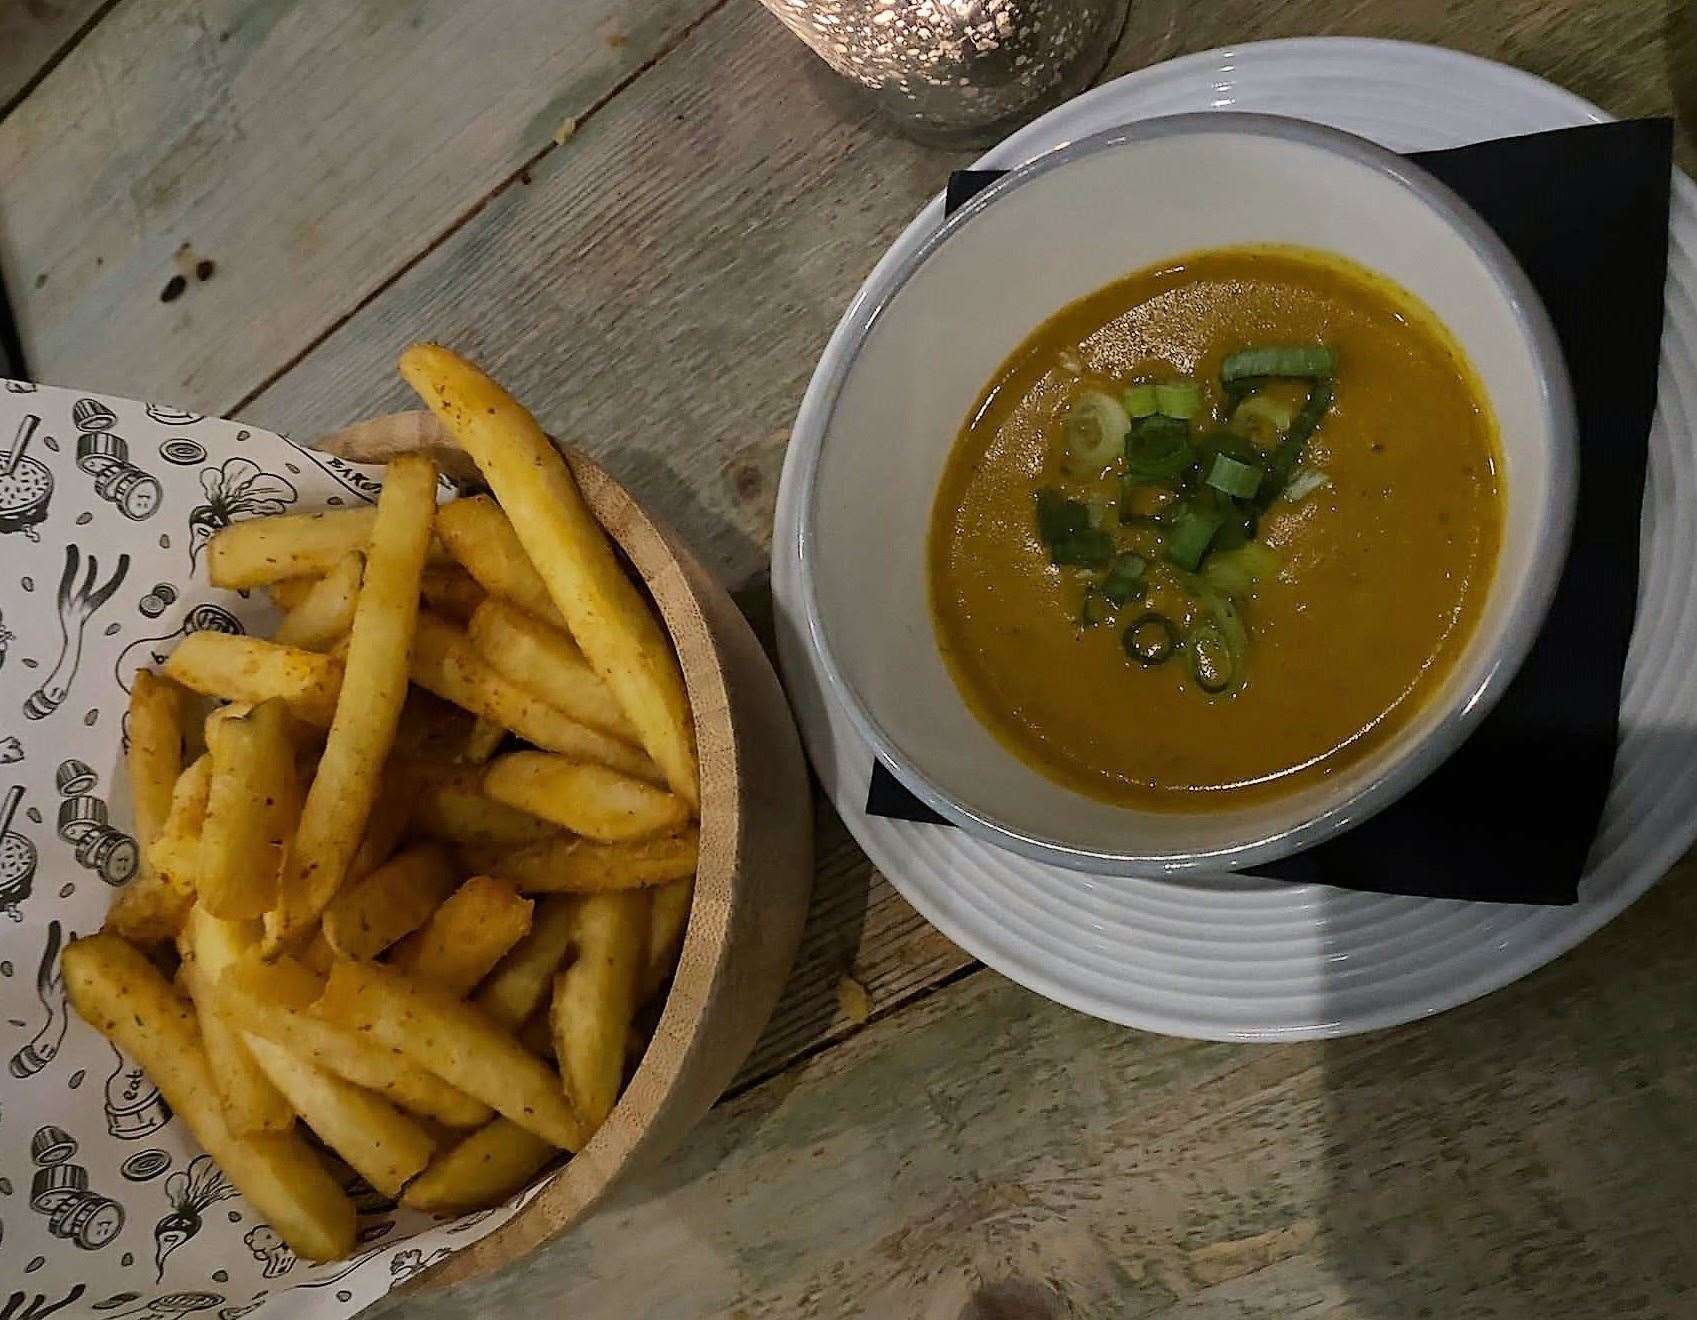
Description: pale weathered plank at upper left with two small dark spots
xmin=0 ymin=0 xmax=720 ymax=411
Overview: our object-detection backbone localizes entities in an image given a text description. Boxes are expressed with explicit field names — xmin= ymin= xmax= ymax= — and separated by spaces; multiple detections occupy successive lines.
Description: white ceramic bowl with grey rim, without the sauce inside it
xmin=799 ymin=114 xmax=1578 ymax=875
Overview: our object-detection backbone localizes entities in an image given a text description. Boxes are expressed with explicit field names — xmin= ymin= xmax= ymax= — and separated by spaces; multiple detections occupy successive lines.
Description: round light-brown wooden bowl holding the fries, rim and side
xmin=317 ymin=412 xmax=813 ymax=1288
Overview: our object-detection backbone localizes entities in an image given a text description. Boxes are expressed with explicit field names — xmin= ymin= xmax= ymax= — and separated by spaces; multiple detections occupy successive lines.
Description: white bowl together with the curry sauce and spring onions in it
xmin=792 ymin=112 xmax=1577 ymax=875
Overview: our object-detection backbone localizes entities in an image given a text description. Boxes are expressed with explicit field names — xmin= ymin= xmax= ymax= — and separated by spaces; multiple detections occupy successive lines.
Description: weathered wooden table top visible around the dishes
xmin=0 ymin=0 xmax=1697 ymax=1320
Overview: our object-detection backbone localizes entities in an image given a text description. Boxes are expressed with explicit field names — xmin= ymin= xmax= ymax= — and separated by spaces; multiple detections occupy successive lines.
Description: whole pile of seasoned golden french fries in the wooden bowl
xmin=63 ymin=344 xmax=699 ymax=1261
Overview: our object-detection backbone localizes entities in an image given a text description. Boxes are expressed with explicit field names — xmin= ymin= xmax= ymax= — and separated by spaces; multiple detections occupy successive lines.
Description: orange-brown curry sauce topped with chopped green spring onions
xmin=928 ymin=246 xmax=1502 ymax=809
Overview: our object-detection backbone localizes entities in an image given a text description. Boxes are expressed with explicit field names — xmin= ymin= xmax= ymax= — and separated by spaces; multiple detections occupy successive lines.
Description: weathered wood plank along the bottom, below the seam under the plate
xmin=370 ymin=848 xmax=1697 ymax=1320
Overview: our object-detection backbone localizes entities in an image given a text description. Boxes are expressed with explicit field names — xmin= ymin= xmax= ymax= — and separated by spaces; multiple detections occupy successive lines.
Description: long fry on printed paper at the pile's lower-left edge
xmin=59 ymin=935 xmax=355 ymax=1261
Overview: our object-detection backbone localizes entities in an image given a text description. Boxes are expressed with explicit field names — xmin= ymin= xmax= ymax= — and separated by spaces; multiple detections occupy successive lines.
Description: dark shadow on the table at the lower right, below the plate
xmin=1313 ymin=838 xmax=1697 ymax=1320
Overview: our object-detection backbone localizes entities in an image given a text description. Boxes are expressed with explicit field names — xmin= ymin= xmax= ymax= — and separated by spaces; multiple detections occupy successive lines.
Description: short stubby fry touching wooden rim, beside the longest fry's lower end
xmin=484 ymin=752 xmax=689 ymax=843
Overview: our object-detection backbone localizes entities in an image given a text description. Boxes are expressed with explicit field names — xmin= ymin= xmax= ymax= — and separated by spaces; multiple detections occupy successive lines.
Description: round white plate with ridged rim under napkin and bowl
xmin=772 ymin=37 xmax=1697 ymax=1040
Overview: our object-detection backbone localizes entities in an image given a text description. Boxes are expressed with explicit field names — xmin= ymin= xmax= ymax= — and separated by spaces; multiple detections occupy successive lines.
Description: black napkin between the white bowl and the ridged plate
xmin=865 ymin=119 xmax=1673 ymax=903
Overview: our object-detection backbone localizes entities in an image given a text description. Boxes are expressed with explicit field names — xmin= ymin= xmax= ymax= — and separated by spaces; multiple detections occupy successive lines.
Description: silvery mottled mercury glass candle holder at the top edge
xmin=762 ymin=0 xmax=1129 ymax=146
